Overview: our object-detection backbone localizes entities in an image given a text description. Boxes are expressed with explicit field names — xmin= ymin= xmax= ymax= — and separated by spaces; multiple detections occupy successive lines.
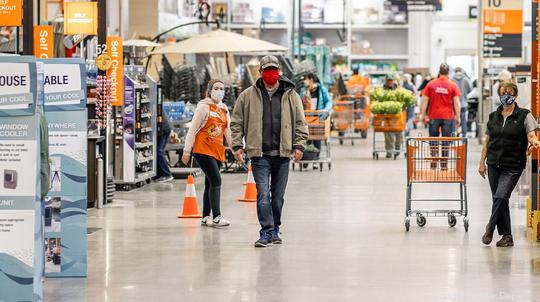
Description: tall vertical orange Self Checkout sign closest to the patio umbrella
xmin=106 ymin=36 xmax=124 ymax=106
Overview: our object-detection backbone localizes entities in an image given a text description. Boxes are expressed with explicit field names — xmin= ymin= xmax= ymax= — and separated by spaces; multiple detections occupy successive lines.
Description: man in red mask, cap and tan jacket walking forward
xmin=231 ymin=56 xmax=308 ymax=247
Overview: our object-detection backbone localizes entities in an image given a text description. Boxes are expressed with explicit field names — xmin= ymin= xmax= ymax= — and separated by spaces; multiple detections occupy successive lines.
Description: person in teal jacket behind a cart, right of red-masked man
xmin=300 ymin=73 xmax=332 ymax=170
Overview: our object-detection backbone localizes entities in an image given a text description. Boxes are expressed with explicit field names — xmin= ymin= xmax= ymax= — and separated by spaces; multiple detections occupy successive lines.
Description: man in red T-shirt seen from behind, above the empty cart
xmin=421 ymin=63 xmax=461 ymax=137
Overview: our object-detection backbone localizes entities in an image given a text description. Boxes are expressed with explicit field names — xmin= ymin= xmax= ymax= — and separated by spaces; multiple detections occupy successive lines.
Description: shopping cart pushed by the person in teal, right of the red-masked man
xmin=292 ymin=110 xmax=332 ymax=172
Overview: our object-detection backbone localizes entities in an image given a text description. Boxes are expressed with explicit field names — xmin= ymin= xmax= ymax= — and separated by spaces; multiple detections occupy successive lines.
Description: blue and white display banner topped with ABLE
xmin=43 ymin=59 xmax=87 ymax=277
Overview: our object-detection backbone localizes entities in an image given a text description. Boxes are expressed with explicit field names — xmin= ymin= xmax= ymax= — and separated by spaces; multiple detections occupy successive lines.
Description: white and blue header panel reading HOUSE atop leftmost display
xmin=0 ymin=57 xmax=37 ymax=116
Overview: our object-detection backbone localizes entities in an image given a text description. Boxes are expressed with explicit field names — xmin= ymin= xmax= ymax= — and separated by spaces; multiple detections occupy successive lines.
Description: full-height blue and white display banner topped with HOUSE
xmin=0 ymin=56 xmax=43 ymax=301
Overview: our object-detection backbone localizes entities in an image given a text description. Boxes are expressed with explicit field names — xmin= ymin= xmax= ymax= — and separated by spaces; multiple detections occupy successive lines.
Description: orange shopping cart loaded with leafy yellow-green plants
xmin=372 ymin=112 xmax=407 ymax=160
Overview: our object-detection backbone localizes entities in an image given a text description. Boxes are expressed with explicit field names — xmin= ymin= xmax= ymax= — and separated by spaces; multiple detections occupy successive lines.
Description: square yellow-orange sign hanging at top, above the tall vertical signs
xmin=63 ymin=0 xmax=98 ymax=35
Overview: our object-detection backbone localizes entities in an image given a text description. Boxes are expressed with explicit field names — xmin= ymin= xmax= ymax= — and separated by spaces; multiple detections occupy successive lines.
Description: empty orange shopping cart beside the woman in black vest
xmin=405 ymin=137 xmax=469 ymax=232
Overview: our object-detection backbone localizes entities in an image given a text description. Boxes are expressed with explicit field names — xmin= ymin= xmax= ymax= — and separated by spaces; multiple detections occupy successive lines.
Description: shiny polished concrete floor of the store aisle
xmin=45 ymin=133 xmax=540 ymax=302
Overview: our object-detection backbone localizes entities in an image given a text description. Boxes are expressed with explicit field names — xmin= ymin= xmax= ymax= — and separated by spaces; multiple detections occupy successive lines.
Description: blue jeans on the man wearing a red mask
xmin=251 ymin=156 xmax=290 ymax=236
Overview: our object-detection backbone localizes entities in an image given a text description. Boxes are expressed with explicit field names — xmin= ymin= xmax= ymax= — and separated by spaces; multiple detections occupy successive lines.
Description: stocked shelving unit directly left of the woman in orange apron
xmin=115 ymin=70 xmax=158 ymax=190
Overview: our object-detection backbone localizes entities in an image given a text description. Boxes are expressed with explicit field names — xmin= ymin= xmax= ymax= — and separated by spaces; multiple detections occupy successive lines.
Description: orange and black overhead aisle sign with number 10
xmin=482 ymin=0 xmax=523 ymax=58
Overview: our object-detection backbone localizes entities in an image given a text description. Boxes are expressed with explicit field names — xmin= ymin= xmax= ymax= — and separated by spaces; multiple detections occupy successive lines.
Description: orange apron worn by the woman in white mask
xmin=193 ymin=104 xmax=227 ymax=162
